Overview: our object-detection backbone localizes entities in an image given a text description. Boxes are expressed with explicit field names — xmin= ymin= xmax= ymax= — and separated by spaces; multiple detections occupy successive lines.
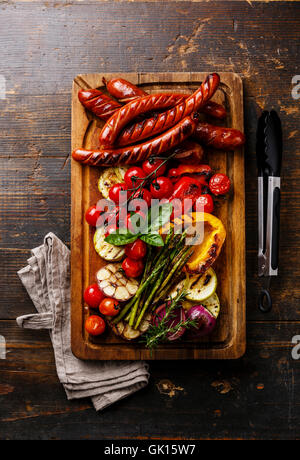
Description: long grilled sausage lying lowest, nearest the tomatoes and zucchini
xmin=72 ymin=113 xmax=198 ymax=166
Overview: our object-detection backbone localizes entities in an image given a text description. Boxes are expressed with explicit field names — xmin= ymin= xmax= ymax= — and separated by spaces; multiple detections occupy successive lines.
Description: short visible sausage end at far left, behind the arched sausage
xmin=78 ymin=89 xmax=121 ymax=121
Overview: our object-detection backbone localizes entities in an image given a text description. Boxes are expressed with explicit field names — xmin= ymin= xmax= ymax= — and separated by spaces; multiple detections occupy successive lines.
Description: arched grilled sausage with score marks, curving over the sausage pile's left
xmin=100 ymin=93 xmax=186 ymax=147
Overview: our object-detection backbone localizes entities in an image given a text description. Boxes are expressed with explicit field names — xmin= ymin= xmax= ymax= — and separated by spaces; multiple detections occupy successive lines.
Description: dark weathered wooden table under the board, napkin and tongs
xmin=0 ymin=0 xmax=300 ymax=439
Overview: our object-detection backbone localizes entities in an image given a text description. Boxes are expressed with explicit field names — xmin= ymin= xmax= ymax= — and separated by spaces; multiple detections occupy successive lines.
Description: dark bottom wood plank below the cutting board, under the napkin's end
xmin=0 ymin=322 xmax=300 ymax=439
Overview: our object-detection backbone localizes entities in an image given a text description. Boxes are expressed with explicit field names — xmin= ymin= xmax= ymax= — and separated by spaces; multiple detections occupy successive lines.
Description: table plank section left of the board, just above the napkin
xmin=0 ymin=156 xmax=70 ymax=249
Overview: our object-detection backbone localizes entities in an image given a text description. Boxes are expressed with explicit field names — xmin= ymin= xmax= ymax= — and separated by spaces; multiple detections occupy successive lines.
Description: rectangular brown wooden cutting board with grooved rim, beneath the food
xmin=71 ymin=72 xmax=246 ymax=360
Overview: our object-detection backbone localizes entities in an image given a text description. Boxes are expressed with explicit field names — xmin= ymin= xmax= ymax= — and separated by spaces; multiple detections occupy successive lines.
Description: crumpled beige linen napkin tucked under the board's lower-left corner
xmin=17 ymin=233 xmax=149 ymax=410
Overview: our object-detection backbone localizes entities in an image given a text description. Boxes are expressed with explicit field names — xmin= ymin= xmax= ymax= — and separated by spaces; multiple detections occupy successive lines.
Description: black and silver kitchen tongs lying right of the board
xmin=256 ymin=110 xmax=282 ymax=313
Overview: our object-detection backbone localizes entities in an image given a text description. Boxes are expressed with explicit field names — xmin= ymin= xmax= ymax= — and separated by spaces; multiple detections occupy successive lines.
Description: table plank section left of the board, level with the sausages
xmin=0 ymin=94 xmax=71 ymax=159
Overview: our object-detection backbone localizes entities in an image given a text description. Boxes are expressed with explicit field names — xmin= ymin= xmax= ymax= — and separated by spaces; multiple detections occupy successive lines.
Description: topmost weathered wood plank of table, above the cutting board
xmin=0 ymin=2 xmax=299 ymax=103
